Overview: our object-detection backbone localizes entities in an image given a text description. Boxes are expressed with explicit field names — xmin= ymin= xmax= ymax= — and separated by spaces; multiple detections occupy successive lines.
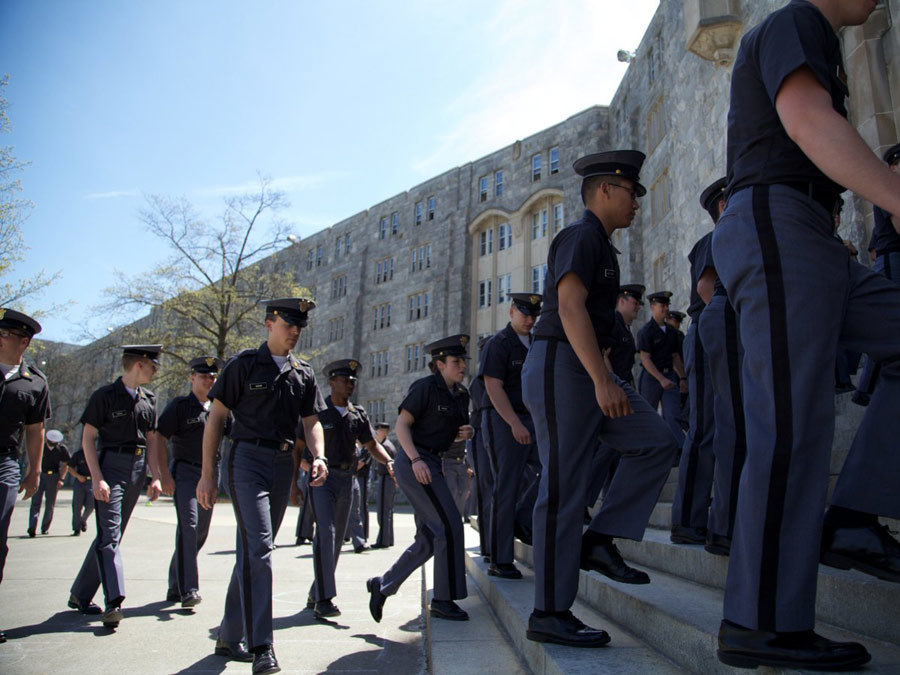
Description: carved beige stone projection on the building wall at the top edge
xmin=684 ymin=0 xmax=744 ymax=66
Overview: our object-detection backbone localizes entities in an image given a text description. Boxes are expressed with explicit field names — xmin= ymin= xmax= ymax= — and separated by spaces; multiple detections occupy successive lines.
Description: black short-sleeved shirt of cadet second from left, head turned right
xmin=81 ymin=377 xmax=156 ymax=449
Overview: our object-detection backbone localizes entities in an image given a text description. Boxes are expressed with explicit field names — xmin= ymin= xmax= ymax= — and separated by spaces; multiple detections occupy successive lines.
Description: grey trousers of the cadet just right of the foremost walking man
xmin=309 ymin=468 xmax=352 ymax=602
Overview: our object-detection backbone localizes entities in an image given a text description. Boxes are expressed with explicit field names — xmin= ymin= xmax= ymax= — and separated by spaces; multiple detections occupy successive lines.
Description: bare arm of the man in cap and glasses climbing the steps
xmin=557 ymin=272 xmax=632 ymax=417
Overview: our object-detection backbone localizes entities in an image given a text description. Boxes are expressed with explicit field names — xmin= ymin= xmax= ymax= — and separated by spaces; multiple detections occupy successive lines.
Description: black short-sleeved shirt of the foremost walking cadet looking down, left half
xmin=209 ymin=342 xmax=325 ymax=443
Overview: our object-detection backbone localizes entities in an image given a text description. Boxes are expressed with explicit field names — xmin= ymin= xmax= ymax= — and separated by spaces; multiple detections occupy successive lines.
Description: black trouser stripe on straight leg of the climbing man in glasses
xmin=543 ymin=340 xmax=560 ymax=612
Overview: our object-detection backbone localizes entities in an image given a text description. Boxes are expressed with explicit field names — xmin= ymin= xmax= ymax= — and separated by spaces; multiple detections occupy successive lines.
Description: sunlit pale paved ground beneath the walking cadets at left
xmin=0 ymin=490 xmax=431 ymax=675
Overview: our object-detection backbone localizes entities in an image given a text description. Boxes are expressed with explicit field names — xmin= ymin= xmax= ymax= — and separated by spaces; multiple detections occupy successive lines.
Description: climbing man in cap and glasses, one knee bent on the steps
xmin=522 ymin=150 xmax=675 ymax=647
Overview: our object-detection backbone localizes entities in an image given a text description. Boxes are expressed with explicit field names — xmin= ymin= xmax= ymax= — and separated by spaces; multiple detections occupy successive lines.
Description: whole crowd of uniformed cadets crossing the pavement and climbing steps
xmin=0 ymin=0 xmax=900 ymax=673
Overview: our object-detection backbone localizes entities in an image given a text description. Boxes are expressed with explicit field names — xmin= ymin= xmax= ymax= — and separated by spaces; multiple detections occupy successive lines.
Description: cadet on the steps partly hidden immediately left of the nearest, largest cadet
xmin=695 ymin=178 xmax=747 ymax=555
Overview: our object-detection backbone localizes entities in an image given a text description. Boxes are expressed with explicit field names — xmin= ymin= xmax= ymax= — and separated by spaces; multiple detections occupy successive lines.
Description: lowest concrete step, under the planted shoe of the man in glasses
xmin=464 ymin=548 xmax=684 ymax=675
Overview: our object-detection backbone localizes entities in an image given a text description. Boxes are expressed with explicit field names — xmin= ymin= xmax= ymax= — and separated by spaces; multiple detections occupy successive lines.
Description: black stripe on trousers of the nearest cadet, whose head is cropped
xmin=753 ymin=185 xmax=794 ymax=631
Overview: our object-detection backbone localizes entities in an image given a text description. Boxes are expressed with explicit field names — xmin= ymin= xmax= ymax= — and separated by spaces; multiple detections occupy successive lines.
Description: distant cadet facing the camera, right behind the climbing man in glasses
xmin=637 ymin=291 xmax=687 ymax=448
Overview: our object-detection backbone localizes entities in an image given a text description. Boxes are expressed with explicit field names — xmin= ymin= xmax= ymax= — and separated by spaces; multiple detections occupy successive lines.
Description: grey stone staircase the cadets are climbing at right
xmin=466 ymin=396 xmax=900 ymax=673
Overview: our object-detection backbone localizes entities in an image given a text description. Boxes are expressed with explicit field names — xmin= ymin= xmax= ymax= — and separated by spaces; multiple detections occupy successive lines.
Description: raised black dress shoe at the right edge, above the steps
xmin=821 ymin=520 xmax=900 ymax=583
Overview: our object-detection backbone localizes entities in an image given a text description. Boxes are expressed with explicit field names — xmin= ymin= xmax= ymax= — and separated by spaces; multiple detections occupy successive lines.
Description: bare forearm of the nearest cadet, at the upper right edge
xmin=775 ymin=66 xmax=900 ymax=227
